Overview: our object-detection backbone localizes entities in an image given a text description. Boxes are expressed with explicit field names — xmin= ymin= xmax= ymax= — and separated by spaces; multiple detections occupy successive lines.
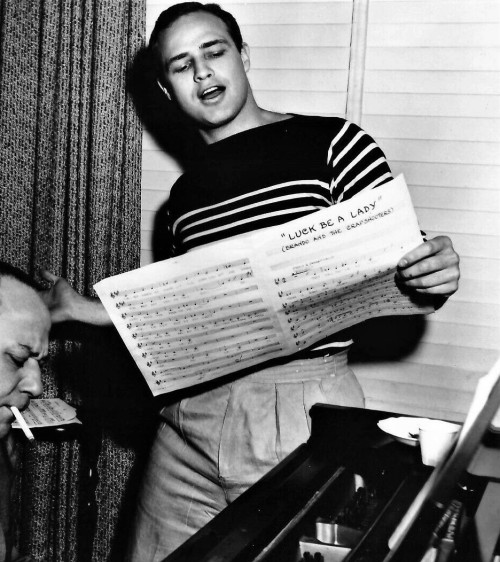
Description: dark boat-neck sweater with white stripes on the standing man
xmin=168 ymin=115 xmax=392 ymax=353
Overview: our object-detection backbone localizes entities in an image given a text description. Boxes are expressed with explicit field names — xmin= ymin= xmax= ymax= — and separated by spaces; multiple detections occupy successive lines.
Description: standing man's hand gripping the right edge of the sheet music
xmin=396 ymin=236 xmax=460 ymax=298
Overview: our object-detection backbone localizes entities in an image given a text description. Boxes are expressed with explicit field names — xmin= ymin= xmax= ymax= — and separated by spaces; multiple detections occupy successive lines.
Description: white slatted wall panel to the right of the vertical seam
xmin=360 ymin=0 xmax=500 ymax=419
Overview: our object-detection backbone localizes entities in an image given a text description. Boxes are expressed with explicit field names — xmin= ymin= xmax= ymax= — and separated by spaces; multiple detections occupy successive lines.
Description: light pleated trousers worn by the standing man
xmin=128 ymin=349 xmax=364 ymax=562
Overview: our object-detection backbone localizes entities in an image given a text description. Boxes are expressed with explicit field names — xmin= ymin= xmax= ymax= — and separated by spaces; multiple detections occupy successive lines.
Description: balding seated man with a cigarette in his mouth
xmin=0 ymin=261 xmax=51 ymax=562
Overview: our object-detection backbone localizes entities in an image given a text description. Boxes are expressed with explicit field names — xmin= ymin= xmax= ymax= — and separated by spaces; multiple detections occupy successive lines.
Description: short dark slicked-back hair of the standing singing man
xmin=149 ymin=2 xmax=243 ymax=53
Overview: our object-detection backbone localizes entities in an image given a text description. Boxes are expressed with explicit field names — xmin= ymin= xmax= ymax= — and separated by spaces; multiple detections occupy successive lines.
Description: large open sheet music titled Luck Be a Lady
xmin=95 ymin=176 xmax=433 ymax=395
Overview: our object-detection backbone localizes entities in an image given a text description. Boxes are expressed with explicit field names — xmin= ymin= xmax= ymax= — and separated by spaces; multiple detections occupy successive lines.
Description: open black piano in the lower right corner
xmin=164 ymin=396 xmax=500 ymax=562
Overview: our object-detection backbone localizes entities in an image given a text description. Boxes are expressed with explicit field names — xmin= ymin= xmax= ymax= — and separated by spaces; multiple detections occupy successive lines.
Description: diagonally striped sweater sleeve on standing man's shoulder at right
xmin=328 ymin=121 xmax=393 ymax=203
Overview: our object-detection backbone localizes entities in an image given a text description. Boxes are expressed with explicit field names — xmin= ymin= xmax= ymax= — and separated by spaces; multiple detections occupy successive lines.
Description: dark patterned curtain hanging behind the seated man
xmin=0 ymin=0 xmax=152 ymax=562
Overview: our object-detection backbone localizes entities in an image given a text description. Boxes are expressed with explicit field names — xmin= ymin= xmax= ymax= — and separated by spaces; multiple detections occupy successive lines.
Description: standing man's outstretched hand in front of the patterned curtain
xmin=40 ymin=270 xmax=111 ymax=326
